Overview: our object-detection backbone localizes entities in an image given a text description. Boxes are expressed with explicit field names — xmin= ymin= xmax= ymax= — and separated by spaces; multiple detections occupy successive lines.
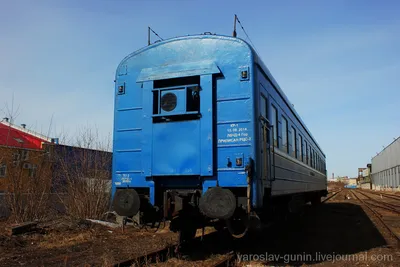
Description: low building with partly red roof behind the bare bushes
xmin=0 ymin=118 xmax=112 ymax=193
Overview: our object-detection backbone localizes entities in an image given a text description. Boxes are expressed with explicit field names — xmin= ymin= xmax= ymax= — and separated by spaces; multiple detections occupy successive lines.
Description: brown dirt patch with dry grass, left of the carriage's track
xmin=0 ymin=219 xmax=177 ymax=267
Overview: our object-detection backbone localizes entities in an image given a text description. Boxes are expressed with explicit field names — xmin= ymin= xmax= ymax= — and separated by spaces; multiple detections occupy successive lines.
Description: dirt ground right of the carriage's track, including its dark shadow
xmin=149 ymin=189 xmax=400 ymax=267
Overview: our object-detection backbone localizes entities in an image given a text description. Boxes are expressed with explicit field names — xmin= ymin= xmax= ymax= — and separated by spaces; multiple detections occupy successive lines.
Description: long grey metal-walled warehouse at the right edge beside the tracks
xmin=371 ymin=137 xmax=400 ymax=188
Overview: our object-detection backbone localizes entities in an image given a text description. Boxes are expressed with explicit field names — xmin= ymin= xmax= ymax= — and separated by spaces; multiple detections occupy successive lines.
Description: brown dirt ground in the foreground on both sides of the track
xmin=0 ymin=189 xmax=400 ymax=266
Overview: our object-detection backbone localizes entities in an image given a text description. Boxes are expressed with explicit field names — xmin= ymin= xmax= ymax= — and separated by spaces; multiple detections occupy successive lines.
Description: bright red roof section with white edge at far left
xmin=0 ymin=119 xmax=52 ymax=149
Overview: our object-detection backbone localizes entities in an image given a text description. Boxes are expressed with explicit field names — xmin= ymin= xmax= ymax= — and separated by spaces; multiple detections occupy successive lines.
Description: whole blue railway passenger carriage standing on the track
xmin=112 ymin=34 xmax=327 ymax=241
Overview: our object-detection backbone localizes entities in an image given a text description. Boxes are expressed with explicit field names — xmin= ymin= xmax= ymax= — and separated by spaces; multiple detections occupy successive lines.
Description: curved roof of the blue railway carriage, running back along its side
xmin=116 ymin=34 xmax=326 ymax=157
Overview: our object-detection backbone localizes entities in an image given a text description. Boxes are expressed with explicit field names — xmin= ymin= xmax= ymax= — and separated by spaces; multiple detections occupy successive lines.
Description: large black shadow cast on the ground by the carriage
xmin=182 ymin=203 xmax=386 ymax=265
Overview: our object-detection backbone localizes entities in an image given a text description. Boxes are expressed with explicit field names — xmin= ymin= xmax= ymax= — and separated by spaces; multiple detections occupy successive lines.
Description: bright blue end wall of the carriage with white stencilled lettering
xmin=113 ymin=35 xmax=255 ymax=207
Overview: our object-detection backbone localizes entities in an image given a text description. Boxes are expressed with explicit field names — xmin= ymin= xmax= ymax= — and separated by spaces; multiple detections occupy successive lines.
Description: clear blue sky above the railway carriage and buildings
xmin=0 ymin=0 xmax=400 ymax=177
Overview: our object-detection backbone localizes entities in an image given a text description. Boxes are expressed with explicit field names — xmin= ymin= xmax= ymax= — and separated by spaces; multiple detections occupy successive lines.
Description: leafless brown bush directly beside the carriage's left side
xmin=52 ymin=125 xmax=112 ymax=222
